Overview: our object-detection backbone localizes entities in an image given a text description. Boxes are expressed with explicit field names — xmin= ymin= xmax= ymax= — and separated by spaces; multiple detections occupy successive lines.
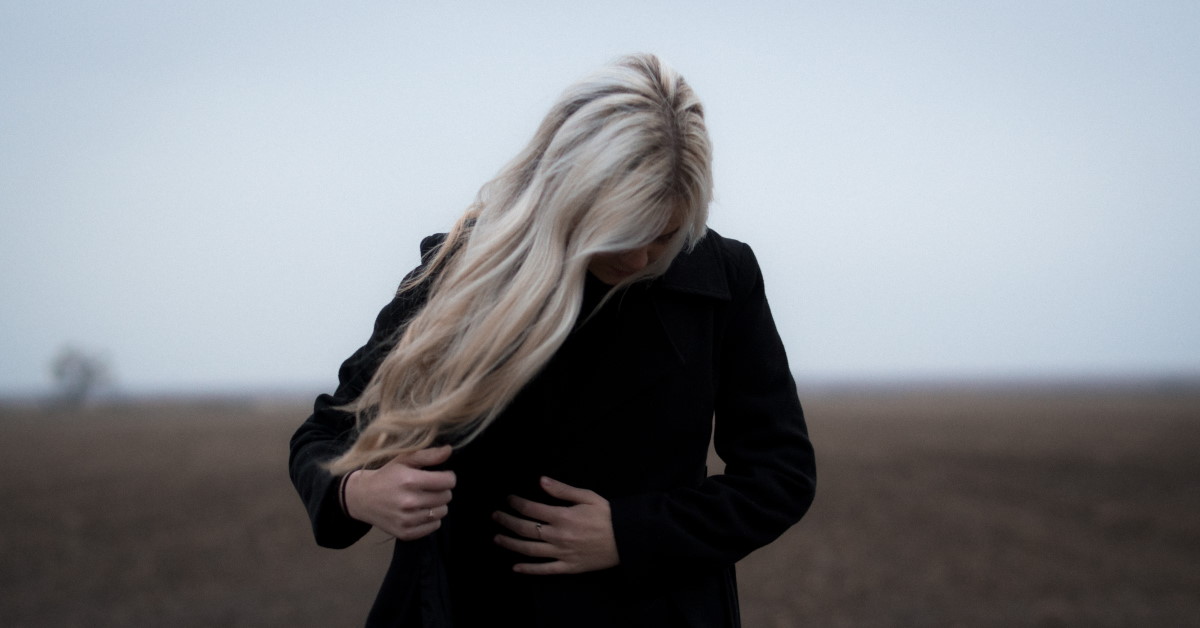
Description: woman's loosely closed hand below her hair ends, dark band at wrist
xmin=346 ymin=445 xmax=455 ymax=540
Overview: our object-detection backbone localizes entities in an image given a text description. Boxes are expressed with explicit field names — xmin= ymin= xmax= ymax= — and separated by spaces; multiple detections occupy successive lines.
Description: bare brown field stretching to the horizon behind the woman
xmin=0 ymin=385 xmax=1200 ymax=628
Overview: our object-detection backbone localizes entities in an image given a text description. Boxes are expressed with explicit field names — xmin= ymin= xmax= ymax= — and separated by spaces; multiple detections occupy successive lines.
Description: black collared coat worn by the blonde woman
xmin=290 ymin=232 xmax=816 ymax=628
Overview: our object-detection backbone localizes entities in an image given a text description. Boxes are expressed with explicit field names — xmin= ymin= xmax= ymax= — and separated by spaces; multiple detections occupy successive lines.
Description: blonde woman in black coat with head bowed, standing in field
xmin=290 ymin=55 xmax=815 ymax=628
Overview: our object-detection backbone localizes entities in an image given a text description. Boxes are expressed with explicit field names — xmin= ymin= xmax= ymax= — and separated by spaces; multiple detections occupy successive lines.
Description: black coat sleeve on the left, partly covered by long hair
xmin=288 ymin=237 xmax=442 ymax=549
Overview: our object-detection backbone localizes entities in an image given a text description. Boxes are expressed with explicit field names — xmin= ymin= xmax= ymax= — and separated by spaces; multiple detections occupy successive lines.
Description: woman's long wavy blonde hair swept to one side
xmin=329 ymin=54 xmax=712 ymax=473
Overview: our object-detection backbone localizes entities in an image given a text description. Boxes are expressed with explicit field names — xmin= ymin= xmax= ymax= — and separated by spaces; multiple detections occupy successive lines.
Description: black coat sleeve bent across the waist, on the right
xmin=612 ymin=243 xmax=816 ymax=570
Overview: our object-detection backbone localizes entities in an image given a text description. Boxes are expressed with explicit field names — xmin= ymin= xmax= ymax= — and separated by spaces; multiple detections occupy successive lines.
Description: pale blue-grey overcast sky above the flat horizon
xmin=0 ymin=0 xmax=1200 ymax=395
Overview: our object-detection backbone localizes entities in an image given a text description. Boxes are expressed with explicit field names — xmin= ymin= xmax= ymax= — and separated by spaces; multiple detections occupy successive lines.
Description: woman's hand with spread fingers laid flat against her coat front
xmin=492 ymin=478 xmax=620 ymax=575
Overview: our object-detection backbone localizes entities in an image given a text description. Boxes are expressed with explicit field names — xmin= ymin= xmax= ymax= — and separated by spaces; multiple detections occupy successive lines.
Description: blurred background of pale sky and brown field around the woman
xmin=0 ymin=0 xmax=1200 ymax=628
